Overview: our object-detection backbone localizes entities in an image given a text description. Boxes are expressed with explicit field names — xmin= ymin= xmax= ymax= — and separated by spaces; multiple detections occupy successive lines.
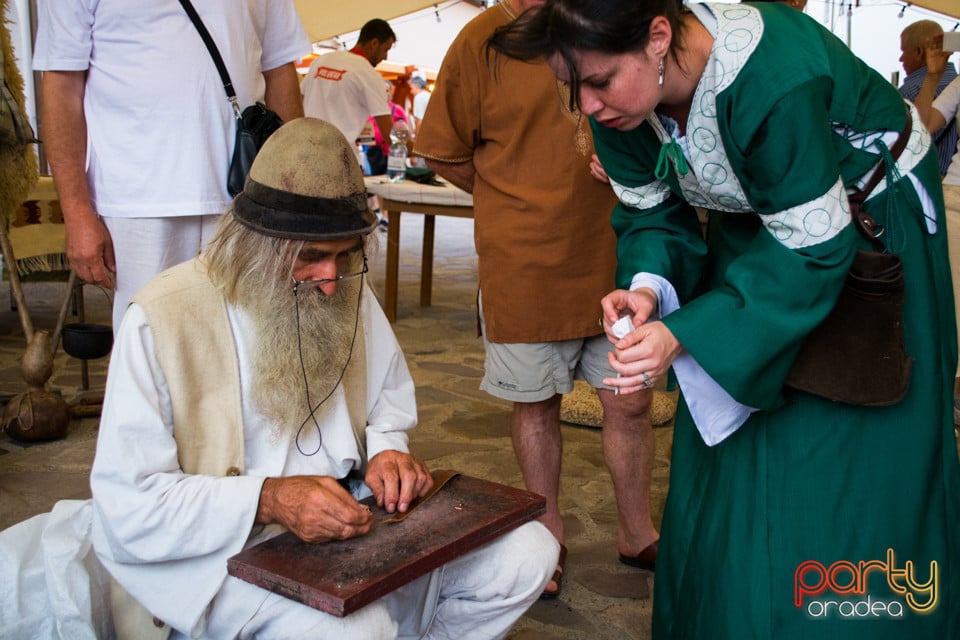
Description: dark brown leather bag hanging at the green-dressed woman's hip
xmin=786 ymin=109 xmax=913 ymax=407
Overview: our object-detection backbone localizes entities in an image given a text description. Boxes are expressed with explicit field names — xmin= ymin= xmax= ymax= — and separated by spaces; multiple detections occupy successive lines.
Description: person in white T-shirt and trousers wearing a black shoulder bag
xmin=33 ymin=0 xmax=310 ymax=331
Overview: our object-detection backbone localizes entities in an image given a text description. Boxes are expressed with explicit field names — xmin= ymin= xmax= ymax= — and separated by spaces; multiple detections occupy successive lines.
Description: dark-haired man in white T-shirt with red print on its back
xmin=300 ymin=18 xmax=397 ymax=154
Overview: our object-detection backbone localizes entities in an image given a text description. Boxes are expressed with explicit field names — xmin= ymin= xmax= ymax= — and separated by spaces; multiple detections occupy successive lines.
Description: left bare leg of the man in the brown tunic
xmin=512 ymin=395 xmax=563 ymax=594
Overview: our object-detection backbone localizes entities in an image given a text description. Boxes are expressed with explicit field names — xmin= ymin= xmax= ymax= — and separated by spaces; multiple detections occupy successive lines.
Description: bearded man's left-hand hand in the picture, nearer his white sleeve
xmin=257 ymin=476 xmax=373 ymax=542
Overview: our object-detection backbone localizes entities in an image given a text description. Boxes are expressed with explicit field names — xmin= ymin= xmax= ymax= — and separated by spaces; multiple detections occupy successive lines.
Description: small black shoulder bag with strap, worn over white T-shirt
xmin=180 ymin=0 xmax=283 ymax=196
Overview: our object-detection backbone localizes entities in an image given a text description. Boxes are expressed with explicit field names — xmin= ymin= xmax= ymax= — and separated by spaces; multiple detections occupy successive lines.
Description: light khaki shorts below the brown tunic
xmin=480 ymin=294 xmax=617 ymax=402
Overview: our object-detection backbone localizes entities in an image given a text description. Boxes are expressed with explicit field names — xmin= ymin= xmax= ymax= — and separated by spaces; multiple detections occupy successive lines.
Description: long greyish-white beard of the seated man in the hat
xmin=238 ymin=277 xmax=361 ymax=436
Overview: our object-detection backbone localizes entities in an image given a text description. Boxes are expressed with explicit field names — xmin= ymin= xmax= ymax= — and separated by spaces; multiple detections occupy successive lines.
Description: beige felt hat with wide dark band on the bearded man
xmin=233 ymin=118 xmax=377 ymax=240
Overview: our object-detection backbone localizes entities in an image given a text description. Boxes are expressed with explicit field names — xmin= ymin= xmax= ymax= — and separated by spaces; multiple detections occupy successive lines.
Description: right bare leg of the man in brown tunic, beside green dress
xmin=597 ymin=389 xmax=660 ymax=556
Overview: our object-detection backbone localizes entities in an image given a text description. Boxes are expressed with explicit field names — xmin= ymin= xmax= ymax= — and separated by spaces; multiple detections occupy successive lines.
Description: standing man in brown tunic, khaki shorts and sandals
xmin=417 ymin=0 xmax=659 ymax=597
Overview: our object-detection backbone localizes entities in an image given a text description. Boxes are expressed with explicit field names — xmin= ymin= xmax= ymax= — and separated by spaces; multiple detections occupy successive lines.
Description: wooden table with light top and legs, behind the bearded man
xmin=364 ymin=176 xmax=473 ymax=322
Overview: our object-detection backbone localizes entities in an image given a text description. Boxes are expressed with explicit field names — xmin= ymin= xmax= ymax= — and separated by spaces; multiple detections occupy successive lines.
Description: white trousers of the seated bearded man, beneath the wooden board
xmin=188 ymin=522 xmax=560 ymax=640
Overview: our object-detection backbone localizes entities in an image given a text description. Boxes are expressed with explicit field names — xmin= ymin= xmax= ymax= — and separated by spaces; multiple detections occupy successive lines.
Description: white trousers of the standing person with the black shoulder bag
xmin=103 ymin=215 xmax=220 ymax=333
